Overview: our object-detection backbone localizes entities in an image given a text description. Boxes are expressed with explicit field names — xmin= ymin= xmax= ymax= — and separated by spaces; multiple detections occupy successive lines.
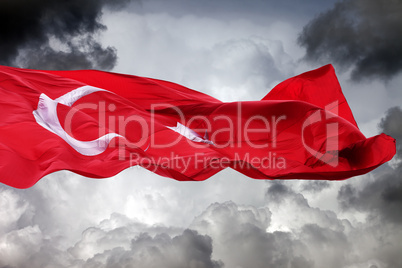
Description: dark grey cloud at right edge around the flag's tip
xmin=338 ymin=107 xmax=402 ymax=225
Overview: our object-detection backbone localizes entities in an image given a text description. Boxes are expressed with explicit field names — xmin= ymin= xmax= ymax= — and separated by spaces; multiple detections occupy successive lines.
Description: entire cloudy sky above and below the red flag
xmin=0 ymin=0 xmax=402 ymax=268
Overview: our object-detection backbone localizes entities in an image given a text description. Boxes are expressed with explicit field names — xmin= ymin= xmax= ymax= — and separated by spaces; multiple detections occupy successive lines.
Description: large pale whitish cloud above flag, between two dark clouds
xmin=100 ymin=12 xmax=296 ymax=101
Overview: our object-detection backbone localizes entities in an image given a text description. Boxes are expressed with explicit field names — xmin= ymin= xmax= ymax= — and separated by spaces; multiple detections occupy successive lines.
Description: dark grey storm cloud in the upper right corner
xmin=298 ymin=0 xmax=402 ymax=80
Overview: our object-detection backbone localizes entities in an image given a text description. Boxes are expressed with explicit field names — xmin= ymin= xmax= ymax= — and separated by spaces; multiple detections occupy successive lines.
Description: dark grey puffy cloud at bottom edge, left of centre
xmin=83 ymin=229 xmax=223 ymax=268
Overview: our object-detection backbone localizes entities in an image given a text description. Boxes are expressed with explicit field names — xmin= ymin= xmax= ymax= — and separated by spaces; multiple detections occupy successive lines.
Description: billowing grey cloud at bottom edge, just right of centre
xmin=191 ymin=202 xmax=312 ymax=268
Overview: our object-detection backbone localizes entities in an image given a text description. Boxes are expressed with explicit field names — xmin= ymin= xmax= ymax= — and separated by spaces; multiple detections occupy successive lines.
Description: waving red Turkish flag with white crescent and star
xmin=0 ymin=65 xmax=395 ymax=188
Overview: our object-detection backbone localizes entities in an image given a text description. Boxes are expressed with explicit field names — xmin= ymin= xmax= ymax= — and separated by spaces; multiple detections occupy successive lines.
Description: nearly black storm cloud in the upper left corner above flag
xmin=0 ymin=0 xmax=130 ymax=69
